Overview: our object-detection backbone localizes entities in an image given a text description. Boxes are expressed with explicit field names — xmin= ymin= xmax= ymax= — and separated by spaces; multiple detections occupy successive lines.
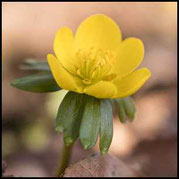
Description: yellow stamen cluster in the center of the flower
xmin=76 ymin=47 xmax=116 ymax=85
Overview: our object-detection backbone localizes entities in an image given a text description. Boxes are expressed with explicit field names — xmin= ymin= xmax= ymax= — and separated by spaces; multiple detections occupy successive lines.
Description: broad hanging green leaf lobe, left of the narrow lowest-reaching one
xmin=80 ymin=95 xmax=101 ymax=149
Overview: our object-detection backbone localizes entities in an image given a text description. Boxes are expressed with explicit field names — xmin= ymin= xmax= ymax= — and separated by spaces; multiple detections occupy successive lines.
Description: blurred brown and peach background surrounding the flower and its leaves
xmin=2 ymin=2 xmax=177 ymax=176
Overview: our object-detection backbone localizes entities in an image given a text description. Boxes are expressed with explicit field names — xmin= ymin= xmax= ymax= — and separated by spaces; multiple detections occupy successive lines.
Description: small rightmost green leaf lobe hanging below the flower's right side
xmin=123 ymin=97 xmax=136 ymax=121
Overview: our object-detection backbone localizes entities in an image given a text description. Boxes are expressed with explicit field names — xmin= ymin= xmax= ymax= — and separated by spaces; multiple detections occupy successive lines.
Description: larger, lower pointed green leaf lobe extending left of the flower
xmin=10 ymin=72 xmax=61 ymax=93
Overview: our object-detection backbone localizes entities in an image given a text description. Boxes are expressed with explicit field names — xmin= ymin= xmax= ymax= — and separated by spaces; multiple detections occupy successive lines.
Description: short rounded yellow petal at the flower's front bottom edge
xmin=83 ymin=81 xmax=117 ymax=98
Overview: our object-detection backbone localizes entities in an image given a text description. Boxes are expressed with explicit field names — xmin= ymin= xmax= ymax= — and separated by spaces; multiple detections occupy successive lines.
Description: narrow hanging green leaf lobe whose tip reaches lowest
xmin=100 ymin=99 xmax=113 ymax=154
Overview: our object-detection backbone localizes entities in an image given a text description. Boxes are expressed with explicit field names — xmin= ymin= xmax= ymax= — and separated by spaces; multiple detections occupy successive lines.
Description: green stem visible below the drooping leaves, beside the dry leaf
xmin=56 ymin=143 xmax=73 ymax=177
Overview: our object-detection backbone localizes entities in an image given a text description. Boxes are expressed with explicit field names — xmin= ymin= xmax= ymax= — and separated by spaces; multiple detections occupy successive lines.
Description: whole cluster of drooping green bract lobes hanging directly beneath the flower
xmin=56 ymin=91 xmax=113 ymax=154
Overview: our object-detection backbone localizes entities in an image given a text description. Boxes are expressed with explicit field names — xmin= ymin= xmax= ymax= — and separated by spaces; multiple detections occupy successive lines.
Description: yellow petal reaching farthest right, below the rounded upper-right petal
xmin=113 ymin=68 xmax=151 ymax=98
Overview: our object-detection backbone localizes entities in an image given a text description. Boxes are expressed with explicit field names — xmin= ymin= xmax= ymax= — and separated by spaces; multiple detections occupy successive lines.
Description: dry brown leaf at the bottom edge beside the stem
xmin=63 ymin=153 xmax=136 ymax=177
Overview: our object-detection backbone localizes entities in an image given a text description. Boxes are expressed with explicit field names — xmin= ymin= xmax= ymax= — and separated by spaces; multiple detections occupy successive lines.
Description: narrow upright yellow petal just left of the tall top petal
xmin=54 ymin=27 xmax=76 ymax=73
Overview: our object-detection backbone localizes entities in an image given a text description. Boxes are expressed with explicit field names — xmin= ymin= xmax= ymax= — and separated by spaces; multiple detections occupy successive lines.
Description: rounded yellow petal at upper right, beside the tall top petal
xmin=114 ymin=37 xmax=144 ymax=78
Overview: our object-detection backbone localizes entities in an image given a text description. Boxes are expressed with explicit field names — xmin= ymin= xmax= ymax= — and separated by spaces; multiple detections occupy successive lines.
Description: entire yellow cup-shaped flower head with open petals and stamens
xmin=47 ymin=14 xmax=150 ymax=98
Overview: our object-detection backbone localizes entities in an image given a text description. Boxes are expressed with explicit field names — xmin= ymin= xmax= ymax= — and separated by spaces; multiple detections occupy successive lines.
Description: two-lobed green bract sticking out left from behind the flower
xmin=10 ymin=59 xmax=61 ymax=93
